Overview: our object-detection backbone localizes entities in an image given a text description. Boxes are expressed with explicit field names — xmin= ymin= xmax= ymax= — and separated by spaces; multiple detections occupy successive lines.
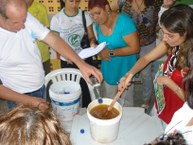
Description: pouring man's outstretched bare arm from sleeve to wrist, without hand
xmin=44 ymin=32 xmax=84 ymax=67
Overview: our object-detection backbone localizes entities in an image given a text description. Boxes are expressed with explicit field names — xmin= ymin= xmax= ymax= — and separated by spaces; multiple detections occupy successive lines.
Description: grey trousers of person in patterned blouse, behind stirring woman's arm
xmin=139 ymin=42 xmax=156 ymax=103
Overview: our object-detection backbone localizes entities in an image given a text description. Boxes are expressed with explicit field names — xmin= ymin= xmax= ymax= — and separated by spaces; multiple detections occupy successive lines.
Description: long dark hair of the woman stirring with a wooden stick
xmin=160 ymin=4 xmax=193 ymax=70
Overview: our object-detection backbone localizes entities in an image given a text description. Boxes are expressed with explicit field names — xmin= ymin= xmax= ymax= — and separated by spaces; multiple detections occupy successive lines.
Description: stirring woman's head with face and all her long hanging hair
xmin=160 ymin=4 xmax=193 ymax=70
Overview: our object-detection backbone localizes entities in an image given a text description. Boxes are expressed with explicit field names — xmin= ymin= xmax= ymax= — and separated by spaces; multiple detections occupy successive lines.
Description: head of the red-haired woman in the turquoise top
xmin=88 ymin=0 xmax=110 ymax=24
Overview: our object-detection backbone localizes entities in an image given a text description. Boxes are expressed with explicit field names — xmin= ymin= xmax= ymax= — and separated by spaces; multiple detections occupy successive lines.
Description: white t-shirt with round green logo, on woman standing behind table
xmin=50 ymin=8 xmax=92 ymax=61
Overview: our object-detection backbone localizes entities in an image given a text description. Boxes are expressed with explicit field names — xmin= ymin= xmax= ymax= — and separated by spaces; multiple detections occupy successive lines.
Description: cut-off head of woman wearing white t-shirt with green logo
xmin=61 ymin=0 xmax=80 ymax=11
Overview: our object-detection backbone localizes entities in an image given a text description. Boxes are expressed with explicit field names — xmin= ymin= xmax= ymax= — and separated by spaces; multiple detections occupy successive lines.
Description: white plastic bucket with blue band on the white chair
xmin=49 ymin=81 xmax=81 ymax=121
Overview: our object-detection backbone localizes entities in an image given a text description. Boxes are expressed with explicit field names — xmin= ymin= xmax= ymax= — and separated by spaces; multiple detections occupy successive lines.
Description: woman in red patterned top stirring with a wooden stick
xmin=119 ymin=4 xmax=193 ymax=123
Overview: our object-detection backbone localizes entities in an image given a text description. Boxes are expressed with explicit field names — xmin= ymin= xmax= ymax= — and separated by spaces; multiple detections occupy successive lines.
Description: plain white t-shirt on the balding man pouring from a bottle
xmin=0 ymin=13 xmax=50 ymax=93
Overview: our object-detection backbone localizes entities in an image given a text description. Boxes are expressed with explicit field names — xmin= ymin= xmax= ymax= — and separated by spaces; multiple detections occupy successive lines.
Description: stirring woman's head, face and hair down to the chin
xmin=160 ymin=4 xmax=193 ymax=47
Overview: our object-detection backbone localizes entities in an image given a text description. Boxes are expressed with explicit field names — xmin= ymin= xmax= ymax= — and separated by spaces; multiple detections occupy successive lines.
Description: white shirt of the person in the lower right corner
xmin=165 ymin=102 xmax=193 ymax=145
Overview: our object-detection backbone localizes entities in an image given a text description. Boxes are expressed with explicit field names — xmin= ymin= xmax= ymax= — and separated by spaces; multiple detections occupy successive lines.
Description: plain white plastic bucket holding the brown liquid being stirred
xmin=87 ymin=98 xmax=122 ymax=143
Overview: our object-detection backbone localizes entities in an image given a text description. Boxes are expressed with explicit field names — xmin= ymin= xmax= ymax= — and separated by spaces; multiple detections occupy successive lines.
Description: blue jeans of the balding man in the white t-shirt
xmin=7 ymin=85 xmax=45 ymax=109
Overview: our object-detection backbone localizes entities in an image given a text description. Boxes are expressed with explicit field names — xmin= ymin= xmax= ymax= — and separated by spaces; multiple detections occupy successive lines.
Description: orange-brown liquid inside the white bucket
xmin=90 ymin=104 xmax=119 ymax=119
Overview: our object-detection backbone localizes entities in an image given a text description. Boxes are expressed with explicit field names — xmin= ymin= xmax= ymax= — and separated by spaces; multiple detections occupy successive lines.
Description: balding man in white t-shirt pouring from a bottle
xmin=0 ymin=0 xmax=102 ymax=109
